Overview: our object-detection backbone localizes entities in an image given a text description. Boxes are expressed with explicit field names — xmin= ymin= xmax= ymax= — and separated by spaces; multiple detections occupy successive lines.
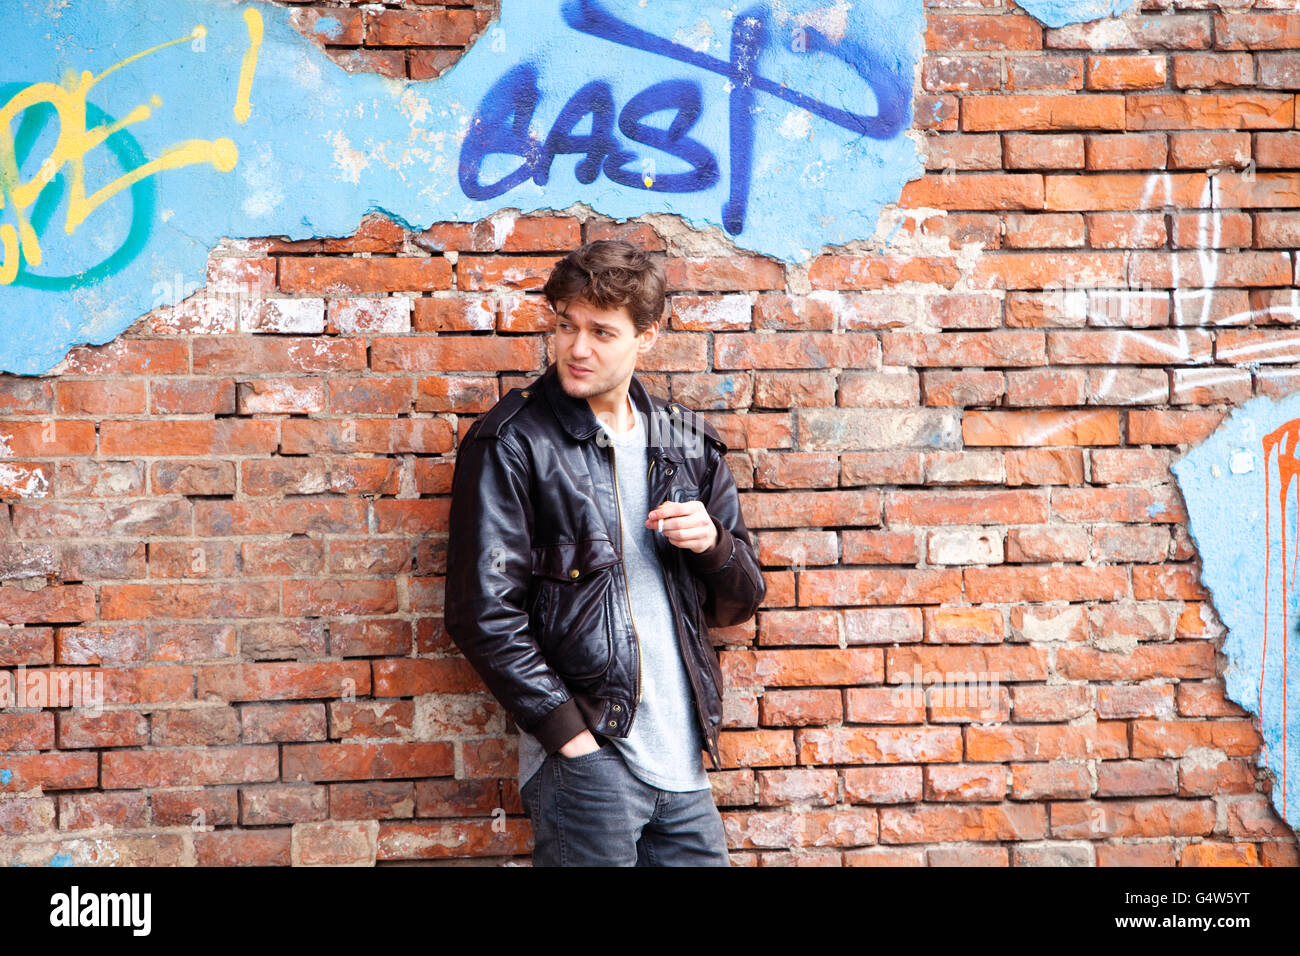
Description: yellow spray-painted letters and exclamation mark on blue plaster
xmin=0 ymin=9 xmax=263 ymax=285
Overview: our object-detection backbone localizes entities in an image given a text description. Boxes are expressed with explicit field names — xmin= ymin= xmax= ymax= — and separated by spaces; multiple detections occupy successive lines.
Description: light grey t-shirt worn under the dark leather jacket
xmin=519 ymin=398 xmax=709 ymax=791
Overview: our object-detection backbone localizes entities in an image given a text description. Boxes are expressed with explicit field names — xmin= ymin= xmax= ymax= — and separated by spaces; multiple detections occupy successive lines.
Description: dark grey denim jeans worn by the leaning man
xmin=520 ymin=743 xmax=731 ymax=866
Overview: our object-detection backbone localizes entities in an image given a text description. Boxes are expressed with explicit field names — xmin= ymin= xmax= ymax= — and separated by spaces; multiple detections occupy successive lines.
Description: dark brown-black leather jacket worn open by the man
xmin=445 ymin=364 xmax=767 ymax=769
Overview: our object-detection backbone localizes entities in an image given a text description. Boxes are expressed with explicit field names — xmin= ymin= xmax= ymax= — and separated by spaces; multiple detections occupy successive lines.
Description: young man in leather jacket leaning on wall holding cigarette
xmin=445 ymin=242 xmax=766 ymax=866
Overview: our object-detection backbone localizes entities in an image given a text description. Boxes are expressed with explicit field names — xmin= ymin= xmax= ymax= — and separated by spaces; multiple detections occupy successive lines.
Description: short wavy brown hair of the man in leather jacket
xmin=542 ymin=239 xmax=668 ymax=336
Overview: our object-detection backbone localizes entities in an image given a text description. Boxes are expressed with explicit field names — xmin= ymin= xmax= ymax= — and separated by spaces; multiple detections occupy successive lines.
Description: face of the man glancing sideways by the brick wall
xmin=551 ymin=299 xmax=658 ymax=399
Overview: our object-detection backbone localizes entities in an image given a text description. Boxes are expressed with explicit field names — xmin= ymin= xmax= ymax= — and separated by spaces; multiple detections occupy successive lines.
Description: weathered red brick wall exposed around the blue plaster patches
xmin=0 ymin=0 xmax=1300 ymax=866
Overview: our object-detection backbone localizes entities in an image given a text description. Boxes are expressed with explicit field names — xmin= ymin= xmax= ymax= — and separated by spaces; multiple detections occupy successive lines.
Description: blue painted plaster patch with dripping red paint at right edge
xmin=1170 ymin=395 xmax=1300 ymax=830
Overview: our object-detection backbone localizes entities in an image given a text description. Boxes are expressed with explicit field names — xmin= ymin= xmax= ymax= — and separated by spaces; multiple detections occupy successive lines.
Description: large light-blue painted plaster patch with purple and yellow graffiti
xmin=0 ymin=0 xmax=924 ymax=375
